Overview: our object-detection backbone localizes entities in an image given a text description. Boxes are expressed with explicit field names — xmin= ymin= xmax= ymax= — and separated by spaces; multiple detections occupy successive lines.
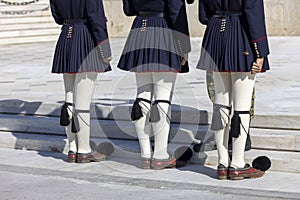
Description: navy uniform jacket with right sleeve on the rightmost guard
xmin=199 ymin=0 xmax=269 ymax=57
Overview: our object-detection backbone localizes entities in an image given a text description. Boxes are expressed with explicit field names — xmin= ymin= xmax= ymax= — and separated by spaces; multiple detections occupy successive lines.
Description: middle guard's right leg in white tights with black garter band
xmin=150 ymin=72 xmax=176 ymax=159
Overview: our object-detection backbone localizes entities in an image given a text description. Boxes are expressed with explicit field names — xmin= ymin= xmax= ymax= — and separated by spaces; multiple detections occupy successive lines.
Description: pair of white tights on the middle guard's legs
xmin=135 ymin=72 xmax=176 ymax=159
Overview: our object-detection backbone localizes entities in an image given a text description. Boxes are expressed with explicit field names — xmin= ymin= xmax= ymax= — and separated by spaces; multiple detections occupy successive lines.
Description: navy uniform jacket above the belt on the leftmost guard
xmin=50 ymin=0 xmax=111 ymax=58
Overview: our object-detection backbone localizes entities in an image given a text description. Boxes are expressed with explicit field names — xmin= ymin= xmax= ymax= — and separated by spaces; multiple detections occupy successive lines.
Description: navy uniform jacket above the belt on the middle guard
xmin=123 ymin=0 xmax=191 ymax=53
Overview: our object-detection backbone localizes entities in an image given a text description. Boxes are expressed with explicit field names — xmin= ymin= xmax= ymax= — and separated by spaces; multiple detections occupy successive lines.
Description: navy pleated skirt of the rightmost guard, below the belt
xmin=197 ymin=16 xmax=269 ymax=72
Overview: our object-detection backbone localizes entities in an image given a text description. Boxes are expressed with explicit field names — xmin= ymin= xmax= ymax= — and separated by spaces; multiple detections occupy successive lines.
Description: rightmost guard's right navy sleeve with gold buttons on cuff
xmin=245 ymin=0 xmax=270 ymax=58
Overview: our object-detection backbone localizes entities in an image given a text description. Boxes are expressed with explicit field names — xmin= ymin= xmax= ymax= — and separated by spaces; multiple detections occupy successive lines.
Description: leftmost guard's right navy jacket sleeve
xmin=86 ymin=0 xmax=111 ymax=58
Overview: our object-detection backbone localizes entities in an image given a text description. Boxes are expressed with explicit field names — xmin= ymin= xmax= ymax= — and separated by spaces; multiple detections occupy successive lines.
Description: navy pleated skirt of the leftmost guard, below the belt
xmin=51 ymin=23 xmax=111 ymax=73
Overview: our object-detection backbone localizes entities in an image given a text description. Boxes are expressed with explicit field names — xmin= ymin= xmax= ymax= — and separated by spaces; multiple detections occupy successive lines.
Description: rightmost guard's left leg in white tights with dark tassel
xmin=211 ymin=72 xmax=232 ymax=169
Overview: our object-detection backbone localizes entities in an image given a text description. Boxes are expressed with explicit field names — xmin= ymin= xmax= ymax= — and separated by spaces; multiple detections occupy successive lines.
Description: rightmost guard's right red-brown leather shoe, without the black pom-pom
xmin=229 ymin=164 xmax=265 ymax=180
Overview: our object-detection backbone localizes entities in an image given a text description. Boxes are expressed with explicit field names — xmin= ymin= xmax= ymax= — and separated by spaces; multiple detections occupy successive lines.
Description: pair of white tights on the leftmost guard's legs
xmin=64 ymin=72 xmax=97 ymax=153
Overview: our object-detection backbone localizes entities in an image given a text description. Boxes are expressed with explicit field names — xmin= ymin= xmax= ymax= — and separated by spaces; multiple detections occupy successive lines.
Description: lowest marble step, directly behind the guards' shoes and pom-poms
xmin=0 ymin=132 xmax=300 ymax=173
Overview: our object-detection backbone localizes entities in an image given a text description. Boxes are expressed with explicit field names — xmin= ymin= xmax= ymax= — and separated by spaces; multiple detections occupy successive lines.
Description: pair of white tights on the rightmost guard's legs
xmin=213 ymin=72 xmax=255 ymax=168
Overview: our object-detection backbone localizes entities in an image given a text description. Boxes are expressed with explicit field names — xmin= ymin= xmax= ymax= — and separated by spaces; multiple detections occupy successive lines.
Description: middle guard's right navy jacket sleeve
xmin=168 ymin=0 xmax=191 ymax=55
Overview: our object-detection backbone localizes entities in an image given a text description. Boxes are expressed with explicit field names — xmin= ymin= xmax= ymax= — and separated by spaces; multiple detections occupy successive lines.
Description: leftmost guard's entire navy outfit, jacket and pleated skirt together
xmin=50 ymin=0 xmax=111 ymax=73
